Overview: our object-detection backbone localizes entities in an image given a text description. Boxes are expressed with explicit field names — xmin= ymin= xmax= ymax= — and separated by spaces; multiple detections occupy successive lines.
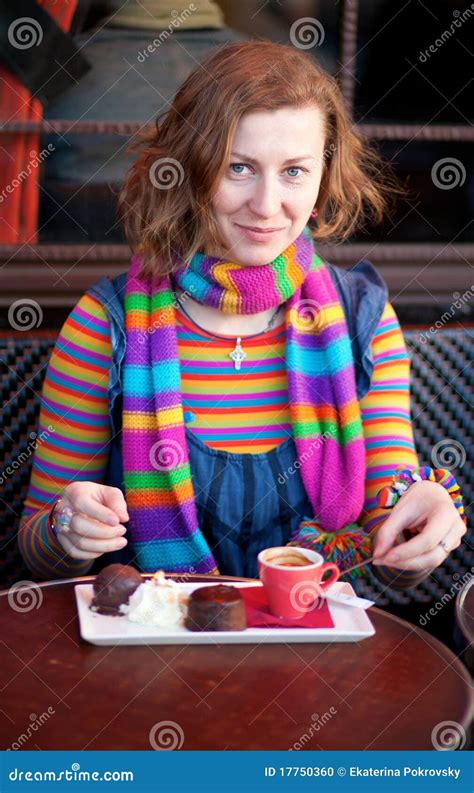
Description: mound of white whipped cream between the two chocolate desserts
xmin=120 ymin=570 xmax=186 ymax=628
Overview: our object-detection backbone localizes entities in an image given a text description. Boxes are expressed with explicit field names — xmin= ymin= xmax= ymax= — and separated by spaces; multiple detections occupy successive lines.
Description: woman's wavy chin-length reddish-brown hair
xmin=118 ymin=41 xmax=401 ymax=276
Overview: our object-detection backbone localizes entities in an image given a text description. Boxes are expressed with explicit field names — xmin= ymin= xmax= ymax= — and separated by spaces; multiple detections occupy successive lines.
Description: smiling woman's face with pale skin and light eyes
xmin=205 ymin=106 xmax=324 ymax=265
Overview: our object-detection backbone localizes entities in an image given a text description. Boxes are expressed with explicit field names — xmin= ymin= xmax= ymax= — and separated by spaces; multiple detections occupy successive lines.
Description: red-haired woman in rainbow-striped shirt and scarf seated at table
xmin=20 ymin=41 xmax=465 ymax=589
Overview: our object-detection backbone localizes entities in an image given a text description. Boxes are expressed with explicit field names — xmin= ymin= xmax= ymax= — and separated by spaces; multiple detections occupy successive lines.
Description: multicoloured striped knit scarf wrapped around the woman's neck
xmin=122 ymin=228 xmax=365 ymax=573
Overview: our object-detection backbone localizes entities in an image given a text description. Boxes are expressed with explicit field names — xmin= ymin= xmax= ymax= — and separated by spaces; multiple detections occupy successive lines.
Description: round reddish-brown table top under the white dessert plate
xmin=0 ymin=576 xmax=472 ymax=750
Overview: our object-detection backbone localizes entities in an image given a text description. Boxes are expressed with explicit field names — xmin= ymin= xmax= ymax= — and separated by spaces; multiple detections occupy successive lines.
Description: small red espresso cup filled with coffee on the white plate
xmin=257 ymin=545 xmax=341 ymax=619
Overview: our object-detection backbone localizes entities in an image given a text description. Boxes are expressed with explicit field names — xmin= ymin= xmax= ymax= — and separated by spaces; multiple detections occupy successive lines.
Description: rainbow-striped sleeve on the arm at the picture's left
xmin=18 ymin=294 xmax=112 ymax=580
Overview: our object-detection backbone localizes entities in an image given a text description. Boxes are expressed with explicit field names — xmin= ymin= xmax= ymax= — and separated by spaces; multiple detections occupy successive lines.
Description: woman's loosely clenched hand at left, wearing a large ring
xmin=57 ymin=482 xmax=129 ymax=559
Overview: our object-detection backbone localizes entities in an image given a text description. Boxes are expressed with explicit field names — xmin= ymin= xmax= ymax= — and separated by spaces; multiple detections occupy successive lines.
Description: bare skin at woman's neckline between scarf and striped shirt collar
xmin=175 ymin=286 xmax=285 ymax=338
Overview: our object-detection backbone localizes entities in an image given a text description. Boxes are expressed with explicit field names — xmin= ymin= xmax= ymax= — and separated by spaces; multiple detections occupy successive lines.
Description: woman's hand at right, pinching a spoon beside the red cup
xmin=373 ymin=480 xmax=466 ymax=573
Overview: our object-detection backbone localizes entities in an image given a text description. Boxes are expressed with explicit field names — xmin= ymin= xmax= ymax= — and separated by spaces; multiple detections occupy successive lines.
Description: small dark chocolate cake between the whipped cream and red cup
xmin=184 ymin=584 xmax=247 ymax=631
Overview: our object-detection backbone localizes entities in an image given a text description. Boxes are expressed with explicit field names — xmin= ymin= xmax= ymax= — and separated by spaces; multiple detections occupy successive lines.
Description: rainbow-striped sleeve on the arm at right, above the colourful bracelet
xmin=359 ymin=303 xmax=426 ymax=590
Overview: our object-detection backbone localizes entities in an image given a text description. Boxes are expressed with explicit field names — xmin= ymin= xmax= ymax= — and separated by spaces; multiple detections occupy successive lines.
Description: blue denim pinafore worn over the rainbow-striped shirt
xmin=88 ymin=260 xmax=388 ymax=578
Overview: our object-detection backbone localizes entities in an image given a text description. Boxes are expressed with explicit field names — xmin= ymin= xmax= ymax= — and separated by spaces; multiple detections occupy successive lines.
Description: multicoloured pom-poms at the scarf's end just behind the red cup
xmin=287 ymin=517 xmax=372 ymax=577
